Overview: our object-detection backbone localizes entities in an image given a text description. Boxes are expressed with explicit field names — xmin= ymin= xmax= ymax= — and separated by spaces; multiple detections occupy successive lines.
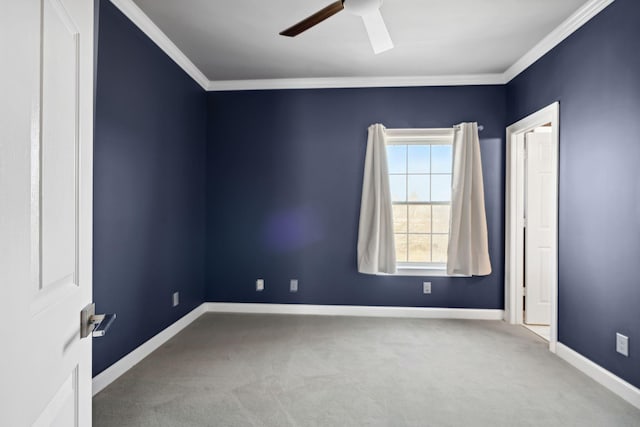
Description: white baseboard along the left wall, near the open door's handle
xmin=93 ymin=304 xmax=205 ymax=396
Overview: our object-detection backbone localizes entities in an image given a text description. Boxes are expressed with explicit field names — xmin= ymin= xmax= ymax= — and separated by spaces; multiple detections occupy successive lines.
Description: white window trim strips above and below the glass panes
xmin=386 ymin=128 xmax=455 ymax=277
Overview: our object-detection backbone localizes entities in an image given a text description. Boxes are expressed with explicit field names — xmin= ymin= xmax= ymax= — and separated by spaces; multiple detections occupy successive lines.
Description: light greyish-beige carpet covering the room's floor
xmin=93 ymin=314 xmax=640 ymax=427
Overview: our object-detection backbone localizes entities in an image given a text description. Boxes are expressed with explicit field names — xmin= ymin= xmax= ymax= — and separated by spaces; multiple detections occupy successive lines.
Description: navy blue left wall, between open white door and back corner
xmin=93 ymin=0 xmax=206 ymax=375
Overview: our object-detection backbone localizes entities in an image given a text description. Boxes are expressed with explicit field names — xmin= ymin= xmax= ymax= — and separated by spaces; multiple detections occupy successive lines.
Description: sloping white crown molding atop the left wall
xmin=110 ymin=0 xmax=210 ymax=90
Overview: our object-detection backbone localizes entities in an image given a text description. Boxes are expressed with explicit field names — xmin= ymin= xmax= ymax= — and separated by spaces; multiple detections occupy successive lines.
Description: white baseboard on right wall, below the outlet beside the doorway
xmin=556 ymin=343 xmax=640 ymax=409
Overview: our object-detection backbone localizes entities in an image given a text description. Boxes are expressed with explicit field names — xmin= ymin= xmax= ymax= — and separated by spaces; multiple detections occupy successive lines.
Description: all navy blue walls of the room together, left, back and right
xmin=94 ymin=0 xmax=640 ymax=392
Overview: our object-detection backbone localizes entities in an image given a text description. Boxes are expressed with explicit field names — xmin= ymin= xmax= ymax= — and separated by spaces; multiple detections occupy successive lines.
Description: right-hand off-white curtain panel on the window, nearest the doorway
xmin=447 ymin=123 xmax=491 ymax=276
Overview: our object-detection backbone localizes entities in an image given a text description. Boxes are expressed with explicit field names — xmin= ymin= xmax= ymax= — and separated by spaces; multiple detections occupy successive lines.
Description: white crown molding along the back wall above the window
xmin=207 ymin=74 xmax=505 ymax=91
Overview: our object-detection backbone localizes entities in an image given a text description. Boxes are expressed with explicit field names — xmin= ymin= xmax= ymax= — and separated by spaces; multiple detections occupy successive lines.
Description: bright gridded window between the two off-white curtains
xmin=387 ymin=129 xmax=453 ymax=270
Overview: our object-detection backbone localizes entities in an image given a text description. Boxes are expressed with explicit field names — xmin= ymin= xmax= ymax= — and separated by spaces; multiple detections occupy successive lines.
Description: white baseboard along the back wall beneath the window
xmin=204 ymin=302 xmax=504 ymax=320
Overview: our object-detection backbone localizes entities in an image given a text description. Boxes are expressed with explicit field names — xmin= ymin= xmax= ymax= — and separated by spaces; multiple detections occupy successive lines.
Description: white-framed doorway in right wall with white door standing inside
xmin=505 ymin=103 xmax=559 ymax=352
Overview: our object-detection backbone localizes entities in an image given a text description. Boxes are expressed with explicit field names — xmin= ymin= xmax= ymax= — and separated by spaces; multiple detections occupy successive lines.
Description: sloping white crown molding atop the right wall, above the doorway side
xmin=503 ymin=0 xmax=614 ymax=83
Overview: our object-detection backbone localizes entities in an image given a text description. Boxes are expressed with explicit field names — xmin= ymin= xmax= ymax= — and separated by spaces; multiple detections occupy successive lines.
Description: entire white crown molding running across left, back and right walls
xmin=110 ymin=0 xmax=614 ymax=91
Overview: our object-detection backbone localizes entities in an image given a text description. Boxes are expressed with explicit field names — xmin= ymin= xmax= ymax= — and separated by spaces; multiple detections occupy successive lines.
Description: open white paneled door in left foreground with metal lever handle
xmin=0 ymin=0 xmax=94 ymax=427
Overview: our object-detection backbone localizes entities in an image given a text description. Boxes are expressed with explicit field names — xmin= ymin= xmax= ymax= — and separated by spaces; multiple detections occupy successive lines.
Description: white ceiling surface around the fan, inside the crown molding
xmin=127 ymin=0 xmax=593 ymax=81
